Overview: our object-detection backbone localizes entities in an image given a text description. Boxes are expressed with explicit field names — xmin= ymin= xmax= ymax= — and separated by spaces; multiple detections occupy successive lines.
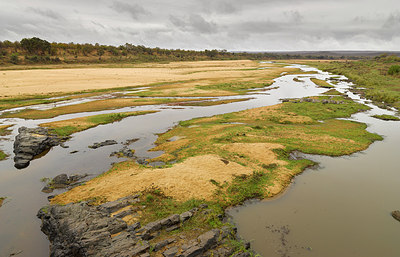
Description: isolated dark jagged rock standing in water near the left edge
xmin=14 ymin=127 xmax=60 ymax=169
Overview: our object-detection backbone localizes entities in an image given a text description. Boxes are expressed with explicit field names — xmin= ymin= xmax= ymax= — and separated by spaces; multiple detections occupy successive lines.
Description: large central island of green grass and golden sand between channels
xmin=47 ymin=93 xmax=382 ymax=256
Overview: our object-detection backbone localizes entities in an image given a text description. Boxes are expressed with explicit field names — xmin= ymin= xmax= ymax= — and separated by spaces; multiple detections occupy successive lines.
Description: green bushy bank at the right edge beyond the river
xmin=312 ymin=55 xmax=400 ymax=109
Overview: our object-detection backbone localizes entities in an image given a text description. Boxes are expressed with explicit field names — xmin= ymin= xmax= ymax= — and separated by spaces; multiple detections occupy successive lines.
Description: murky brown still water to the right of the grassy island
xmin=229 ymin=70 xmax=400 ymax=257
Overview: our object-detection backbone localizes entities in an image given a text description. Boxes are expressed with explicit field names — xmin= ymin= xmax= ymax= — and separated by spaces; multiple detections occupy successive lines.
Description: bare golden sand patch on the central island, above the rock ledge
xmin=52 ymin=155 xmax=252 ymax=204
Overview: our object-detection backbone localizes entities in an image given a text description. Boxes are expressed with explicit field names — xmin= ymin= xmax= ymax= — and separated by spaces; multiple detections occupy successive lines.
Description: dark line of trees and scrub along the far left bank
xmin=0 ymin=37 xmax=368 ymax=65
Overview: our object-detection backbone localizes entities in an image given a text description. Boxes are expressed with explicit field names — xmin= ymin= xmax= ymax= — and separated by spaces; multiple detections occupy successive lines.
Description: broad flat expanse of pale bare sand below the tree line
xmin=0 ymin=60 xmax=272 ymax=97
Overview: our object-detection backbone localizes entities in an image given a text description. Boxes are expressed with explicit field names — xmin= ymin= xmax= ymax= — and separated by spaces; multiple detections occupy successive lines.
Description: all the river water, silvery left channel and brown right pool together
xmin=0 ymin=65 xmax=400 ymax=254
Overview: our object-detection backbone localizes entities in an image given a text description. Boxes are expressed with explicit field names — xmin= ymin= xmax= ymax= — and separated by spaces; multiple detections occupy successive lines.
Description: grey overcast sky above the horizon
xmin=0 ymin=0 xmax=400 ymax=51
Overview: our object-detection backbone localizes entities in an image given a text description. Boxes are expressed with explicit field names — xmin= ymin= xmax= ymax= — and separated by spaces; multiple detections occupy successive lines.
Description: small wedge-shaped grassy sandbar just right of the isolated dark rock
xmin=40 ymin=111 xmax=157 ymax=137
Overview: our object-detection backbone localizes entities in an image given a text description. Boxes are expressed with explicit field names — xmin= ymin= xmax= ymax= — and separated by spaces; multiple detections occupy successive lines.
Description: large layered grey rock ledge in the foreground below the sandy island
xmin=38 ymin=195 xmax=249 ymax=257
